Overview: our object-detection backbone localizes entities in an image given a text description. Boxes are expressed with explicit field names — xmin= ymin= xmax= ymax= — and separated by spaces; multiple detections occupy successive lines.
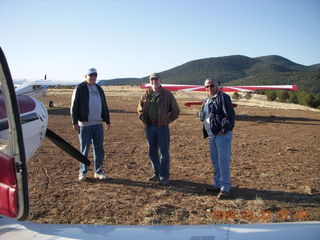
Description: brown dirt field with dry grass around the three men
xmin=28 ymin=87 xmax=320 ymax=225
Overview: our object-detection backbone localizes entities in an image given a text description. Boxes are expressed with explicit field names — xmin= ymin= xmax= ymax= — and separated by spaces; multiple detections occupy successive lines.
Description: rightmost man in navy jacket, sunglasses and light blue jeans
xmin=200 ymin=79 xmax=235 ymax=199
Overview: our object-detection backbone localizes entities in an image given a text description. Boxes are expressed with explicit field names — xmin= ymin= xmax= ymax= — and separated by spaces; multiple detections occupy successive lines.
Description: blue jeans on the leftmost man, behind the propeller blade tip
xmin=78 ymin=124 xmax=104 ymax=174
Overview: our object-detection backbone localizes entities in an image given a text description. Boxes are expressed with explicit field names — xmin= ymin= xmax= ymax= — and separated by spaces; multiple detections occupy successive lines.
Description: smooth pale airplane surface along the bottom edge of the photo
xmin=0 ymin=216 xmax=320 ymax=240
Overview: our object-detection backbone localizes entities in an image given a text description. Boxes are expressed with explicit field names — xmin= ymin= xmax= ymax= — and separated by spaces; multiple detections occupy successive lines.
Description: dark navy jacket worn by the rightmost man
xmin=201 ymin=92 xmax=235 ymax=138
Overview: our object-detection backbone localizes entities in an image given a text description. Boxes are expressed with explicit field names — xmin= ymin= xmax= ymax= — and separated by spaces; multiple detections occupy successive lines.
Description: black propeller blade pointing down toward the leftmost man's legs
xmin=46 ymin=128 xmax=91 ymax=166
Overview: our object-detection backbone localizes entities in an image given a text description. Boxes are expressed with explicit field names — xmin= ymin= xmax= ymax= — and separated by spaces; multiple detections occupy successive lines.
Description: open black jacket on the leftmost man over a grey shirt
xmin=70 ymin=82 xmax=110 ymax=125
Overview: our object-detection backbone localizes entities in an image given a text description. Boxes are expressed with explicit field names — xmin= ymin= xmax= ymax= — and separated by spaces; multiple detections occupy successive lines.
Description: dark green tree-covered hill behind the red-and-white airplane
xmin=101 ymin=55 xmax=320 ymax=93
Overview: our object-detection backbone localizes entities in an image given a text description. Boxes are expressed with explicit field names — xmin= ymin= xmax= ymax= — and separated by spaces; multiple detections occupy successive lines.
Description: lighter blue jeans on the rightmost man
xmin=210 ymin=131 xmax=233 ymax=192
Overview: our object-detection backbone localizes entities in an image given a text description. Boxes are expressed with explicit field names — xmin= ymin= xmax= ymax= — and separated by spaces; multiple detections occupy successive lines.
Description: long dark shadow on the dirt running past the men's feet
xmin=86 ymin=178 xmax=320 ymax=204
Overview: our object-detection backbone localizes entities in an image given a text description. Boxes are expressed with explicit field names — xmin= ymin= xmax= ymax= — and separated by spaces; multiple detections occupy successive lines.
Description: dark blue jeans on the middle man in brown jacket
xmin=146 ymin=124 xmax=170 ymax=179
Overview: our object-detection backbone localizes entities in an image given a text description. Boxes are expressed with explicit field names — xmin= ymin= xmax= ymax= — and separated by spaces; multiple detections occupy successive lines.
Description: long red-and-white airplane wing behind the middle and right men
xmin=140 ymin=83 xmax=298 ymax=92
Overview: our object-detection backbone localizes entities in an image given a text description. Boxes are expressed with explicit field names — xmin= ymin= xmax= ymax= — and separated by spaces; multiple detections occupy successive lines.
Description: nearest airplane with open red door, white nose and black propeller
xmin=0 ymin=48 xmax=320 ymax=240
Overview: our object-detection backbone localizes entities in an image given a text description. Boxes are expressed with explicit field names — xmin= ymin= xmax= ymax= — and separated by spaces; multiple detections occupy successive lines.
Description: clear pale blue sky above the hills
xmin=0 ymin=0 xmax=320 ymax=81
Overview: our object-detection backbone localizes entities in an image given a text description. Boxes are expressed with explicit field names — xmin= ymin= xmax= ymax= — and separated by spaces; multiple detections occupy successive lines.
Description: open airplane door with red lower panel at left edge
xmin=0 ymin=48 xmax=29 ymax=220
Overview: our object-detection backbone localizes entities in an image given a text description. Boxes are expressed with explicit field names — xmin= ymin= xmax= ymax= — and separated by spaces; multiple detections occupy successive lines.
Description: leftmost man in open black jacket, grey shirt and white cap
xmin=70 ymin=68 xmax=111 ymax=181
